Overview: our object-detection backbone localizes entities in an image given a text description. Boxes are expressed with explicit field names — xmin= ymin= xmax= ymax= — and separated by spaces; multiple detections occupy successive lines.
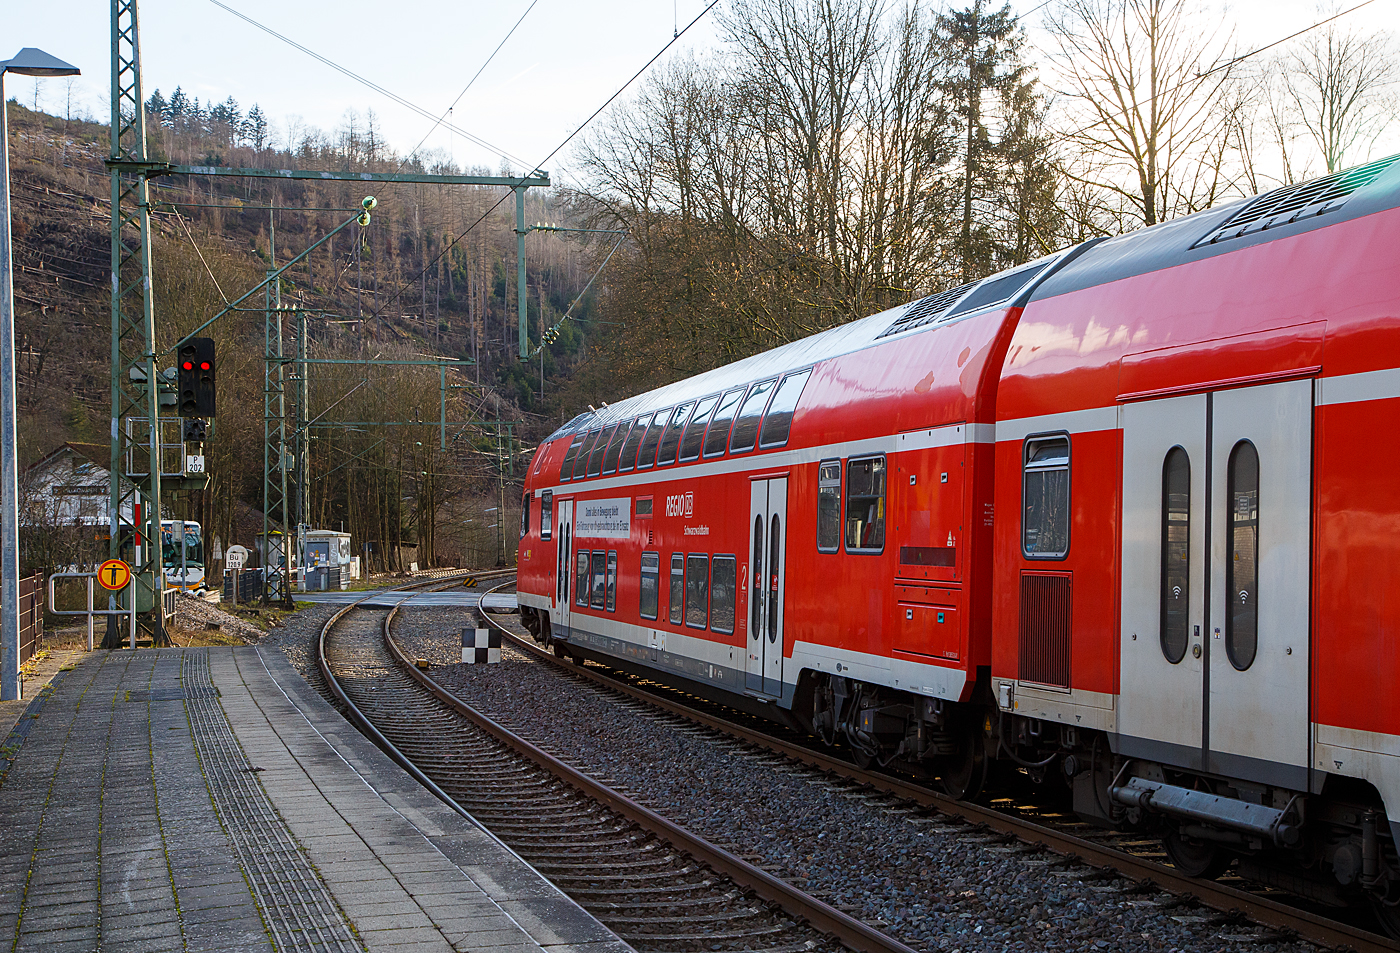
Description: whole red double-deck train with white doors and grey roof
xmin=518 ymin=153 xmax=1400 ymax=929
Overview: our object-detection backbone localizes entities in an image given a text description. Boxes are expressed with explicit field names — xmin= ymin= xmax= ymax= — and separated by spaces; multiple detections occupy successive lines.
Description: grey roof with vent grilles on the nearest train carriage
xmin=1030 ymin=155 xmax=1400 ymax=301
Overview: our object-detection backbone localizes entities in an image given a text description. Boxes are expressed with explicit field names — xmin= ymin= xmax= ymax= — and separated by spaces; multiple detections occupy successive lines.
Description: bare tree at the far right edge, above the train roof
xmin=1282 ymin=13 xmax=1397 ymax=172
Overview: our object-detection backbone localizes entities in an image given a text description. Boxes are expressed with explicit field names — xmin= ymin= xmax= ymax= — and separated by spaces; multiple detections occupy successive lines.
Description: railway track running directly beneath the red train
xmin=483 ymin=584 xmax=1400 ymax=953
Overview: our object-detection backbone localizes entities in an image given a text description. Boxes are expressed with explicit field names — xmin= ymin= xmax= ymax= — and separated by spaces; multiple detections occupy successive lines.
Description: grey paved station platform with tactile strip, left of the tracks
xmin=0 ymin=648 xmax=631 ymax=953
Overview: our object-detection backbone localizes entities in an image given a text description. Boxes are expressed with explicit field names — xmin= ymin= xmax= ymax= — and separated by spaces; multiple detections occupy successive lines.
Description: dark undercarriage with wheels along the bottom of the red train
xmin=521 ymin=609 xmax=1400 ymax=938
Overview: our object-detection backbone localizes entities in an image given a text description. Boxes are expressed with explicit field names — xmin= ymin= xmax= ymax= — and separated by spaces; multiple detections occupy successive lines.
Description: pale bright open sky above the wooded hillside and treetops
xmin=0 ymin=0 xmax=1400 ymax=183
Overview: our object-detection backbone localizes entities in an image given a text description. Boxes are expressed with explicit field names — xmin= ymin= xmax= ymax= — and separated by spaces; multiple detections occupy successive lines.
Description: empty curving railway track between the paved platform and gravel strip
xmin=316 ymin=573 xmax=913 ymax=953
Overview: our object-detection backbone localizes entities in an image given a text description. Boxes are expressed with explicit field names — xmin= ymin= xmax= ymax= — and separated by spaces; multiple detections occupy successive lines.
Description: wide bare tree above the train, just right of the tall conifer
xmin=1046 ymin=0 xmax=1235 ymax=227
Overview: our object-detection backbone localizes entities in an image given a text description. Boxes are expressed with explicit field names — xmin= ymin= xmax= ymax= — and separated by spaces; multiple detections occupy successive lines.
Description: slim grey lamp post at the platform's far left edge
xmin=0 ymin=46 xmax=78 ymax=701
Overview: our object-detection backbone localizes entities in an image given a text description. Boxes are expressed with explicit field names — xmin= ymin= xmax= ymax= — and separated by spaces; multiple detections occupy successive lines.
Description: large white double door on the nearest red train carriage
xmin=1119 ymin=381 xmax=1313 ymax=786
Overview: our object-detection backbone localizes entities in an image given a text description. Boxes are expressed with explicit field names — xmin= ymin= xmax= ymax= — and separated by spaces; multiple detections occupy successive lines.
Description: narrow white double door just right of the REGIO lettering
xmin=745 ymin=477 xmax=787 ymax=697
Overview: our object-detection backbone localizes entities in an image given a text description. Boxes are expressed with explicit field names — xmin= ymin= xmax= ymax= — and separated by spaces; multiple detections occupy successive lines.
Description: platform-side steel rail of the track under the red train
xmin=479 ymin=584 xmax=1400 ymax=953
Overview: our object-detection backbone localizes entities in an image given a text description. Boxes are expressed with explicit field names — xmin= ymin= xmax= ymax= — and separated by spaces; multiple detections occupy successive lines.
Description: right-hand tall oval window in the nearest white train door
xmin=1225 ymin=439 xmax=1259 ymax=672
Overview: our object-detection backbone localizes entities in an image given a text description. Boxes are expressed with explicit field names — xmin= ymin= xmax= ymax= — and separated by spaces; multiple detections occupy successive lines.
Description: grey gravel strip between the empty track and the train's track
xmin=396 ymin=609 xmax=1317 ymax=953
